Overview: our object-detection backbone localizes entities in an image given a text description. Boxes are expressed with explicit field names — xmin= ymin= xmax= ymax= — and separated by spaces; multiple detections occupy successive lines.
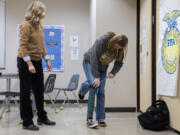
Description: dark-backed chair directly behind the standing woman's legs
xmin=44 ymin=74 xmax=58 ymax=113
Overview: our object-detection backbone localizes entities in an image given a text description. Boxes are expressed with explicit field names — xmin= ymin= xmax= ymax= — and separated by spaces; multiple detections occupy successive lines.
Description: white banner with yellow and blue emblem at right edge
xmin=157 ymin=0 xmax=180 ymax=96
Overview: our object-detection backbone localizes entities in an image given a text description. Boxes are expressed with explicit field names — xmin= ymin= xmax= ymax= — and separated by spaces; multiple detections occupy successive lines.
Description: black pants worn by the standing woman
xmin=17 ymin=58 xmax=47 ymax=126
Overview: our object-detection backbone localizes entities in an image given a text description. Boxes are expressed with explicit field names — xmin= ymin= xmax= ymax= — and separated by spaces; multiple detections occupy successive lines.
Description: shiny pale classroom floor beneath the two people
xmin=0 ymin=105 xmax=177 ymax=135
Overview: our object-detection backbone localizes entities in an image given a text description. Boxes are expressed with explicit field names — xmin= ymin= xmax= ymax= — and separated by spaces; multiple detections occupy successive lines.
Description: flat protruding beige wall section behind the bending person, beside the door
xmin=96 ymin=0 xmax=137 ymax=107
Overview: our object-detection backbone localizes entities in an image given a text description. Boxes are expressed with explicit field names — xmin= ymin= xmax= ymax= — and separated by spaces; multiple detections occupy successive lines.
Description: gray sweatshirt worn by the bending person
xmin=84 ymin=35 xmax=123 ymax=78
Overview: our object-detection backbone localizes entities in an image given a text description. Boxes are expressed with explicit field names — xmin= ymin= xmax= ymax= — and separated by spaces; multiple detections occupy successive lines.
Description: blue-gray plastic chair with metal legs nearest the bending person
xmin=54 ymin=74 xmax=79 ymax=109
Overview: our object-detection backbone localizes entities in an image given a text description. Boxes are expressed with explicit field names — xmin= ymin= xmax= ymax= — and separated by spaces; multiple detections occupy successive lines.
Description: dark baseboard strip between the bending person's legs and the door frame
xmin=105 ymin=107 xmax=136 ymax=112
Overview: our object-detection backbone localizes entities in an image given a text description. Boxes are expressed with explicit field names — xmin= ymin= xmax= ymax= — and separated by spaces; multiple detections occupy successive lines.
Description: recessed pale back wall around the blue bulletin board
xmin=0 ymin=0 xmax=90 ymax=99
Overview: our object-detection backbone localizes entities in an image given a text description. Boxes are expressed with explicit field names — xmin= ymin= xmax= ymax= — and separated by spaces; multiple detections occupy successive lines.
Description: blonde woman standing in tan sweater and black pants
xmin=17 ymin=1 xmax=56 ymax=131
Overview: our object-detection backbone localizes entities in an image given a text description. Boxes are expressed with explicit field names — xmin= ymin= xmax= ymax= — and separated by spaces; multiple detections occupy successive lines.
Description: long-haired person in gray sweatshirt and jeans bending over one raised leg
xmin=79 ymin=32 xmax=128 ymax=128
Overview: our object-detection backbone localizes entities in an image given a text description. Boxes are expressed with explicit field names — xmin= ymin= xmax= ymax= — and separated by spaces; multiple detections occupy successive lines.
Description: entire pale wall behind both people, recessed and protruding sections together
xmin=0 ymin=0 xmax=136 ymax=107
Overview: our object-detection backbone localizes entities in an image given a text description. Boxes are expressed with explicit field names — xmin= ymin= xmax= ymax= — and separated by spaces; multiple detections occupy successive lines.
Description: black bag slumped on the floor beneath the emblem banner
xmin=138 ymin=99 xmax=169 ymax=131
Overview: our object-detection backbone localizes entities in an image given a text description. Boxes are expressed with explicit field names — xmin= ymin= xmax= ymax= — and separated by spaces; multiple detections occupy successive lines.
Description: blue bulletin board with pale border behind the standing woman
xmin=17 ymin=24 xmax=65 ymax=71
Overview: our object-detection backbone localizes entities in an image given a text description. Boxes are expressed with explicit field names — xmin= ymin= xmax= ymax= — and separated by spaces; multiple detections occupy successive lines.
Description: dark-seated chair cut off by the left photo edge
xmin=0 ymin=92 xmax=20 ymax=119
